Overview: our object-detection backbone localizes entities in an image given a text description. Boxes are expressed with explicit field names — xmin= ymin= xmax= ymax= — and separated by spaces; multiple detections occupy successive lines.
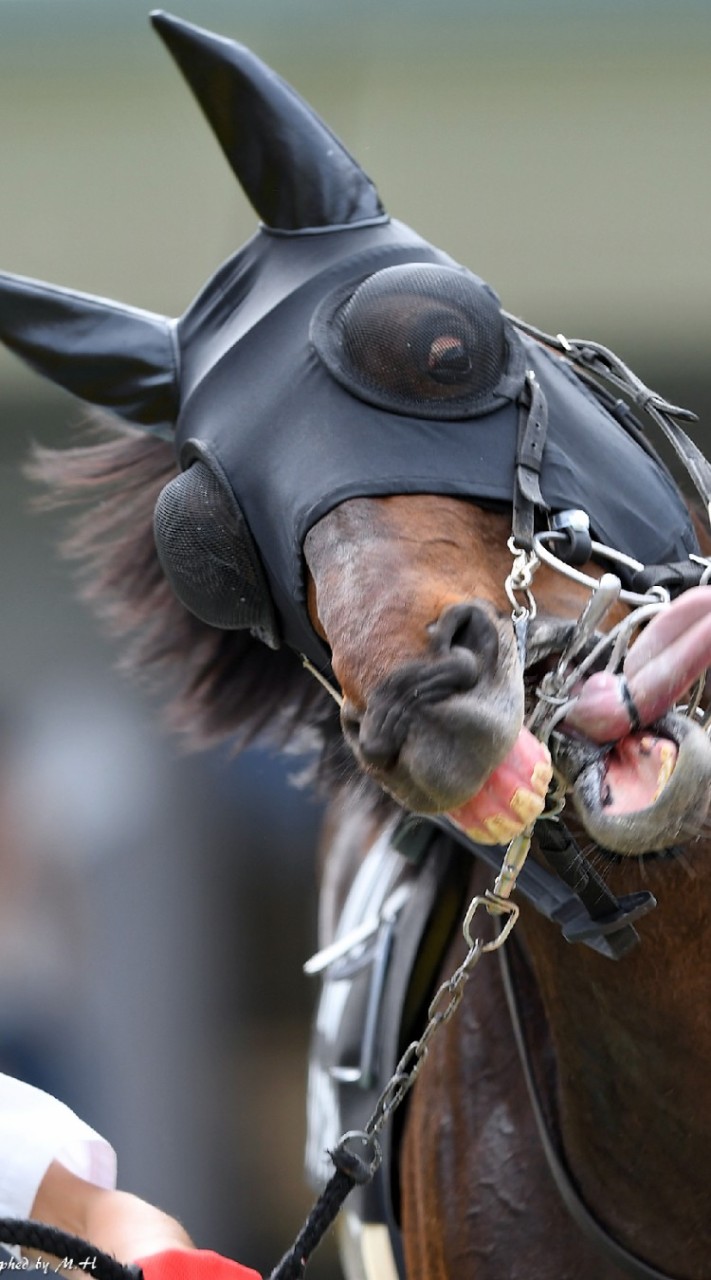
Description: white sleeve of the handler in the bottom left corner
xmin=0 ymin=1074 xmax=117 ymax=1217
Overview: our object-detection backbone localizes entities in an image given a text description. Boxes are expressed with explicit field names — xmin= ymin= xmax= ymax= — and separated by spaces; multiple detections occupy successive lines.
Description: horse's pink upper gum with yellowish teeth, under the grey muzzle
xmin=450 ymin=728 xmax=552 ymax=845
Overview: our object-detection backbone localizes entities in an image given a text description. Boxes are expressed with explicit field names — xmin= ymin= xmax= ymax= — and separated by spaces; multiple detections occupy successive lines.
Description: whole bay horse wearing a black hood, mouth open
xmin=0 ymin=13 xmax=711 ymax=1280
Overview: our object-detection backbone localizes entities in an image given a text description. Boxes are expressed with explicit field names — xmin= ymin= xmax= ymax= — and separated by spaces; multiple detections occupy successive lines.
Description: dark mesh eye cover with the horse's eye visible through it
xmin=311 ymin=264 xmax=525 ymax=419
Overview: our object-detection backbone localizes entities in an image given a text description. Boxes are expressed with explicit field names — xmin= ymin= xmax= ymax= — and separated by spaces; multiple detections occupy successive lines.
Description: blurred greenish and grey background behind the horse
xmin=0 ymin=0 xmax=711 ymax=1277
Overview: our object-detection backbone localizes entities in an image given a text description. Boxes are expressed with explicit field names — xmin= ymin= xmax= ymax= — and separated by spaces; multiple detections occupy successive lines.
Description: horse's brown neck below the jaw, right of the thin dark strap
xmin=521 ymin=842 xmax=711 ymax=1280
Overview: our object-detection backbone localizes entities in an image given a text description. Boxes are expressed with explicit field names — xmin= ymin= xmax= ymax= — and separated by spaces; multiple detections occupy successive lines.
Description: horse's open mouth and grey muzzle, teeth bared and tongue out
xmin=348 ymin=599 xmax=711 ymax=856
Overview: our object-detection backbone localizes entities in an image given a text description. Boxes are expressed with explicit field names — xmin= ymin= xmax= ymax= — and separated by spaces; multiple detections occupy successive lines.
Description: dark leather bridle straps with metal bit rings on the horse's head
xmin=301 ymin=320 xmax=711 ymax=959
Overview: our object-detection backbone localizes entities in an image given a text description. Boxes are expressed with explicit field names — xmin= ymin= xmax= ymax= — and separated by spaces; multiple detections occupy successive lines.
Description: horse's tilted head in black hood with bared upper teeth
xmin=0 ymin=13 xmax=711 ymax=852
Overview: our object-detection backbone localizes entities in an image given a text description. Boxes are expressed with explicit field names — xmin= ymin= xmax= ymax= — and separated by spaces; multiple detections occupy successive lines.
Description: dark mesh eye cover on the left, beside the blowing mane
xmin=154 ymin=458 xmax=279 ymax=649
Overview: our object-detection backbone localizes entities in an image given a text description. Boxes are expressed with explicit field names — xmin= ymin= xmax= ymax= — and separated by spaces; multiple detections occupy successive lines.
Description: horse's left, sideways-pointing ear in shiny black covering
xmin=0 ymin=273 xmax=178 ymax=436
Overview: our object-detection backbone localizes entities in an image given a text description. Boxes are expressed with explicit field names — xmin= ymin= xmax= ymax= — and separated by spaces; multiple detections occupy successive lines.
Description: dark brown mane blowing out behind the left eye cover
xmin=26 ymin=413 xmax=374 ymax=794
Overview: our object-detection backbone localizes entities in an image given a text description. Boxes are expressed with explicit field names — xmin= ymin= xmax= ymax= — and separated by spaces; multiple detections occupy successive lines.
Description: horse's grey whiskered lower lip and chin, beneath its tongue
xmin=553 ymin=713 xmax=711 ymax=856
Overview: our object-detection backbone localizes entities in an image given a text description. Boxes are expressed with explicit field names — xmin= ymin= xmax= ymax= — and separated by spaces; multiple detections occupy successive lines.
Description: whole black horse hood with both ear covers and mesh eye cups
xmin=0 ymin=13 xmax=696 ymax=663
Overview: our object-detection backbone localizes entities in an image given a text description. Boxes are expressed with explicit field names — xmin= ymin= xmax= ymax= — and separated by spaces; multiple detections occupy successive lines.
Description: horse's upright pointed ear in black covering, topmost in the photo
xmin=151 ymin=12 xmax=384 ymax=232
